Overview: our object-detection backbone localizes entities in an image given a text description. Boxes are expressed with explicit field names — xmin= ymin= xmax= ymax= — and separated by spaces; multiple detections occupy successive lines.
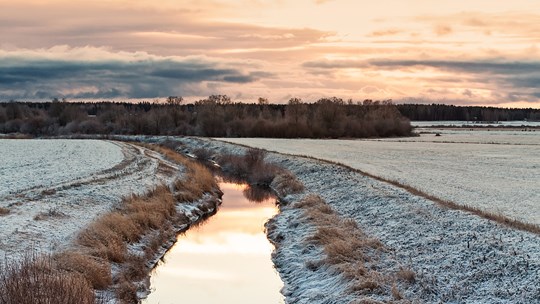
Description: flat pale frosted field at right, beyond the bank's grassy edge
xmin=226 ymin=130 xmax=540 ymax=224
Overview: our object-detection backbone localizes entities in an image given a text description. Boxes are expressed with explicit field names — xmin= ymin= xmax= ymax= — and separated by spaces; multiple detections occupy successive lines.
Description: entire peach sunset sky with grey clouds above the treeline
xmin=0 ymin=0 xmax=540 ymax=108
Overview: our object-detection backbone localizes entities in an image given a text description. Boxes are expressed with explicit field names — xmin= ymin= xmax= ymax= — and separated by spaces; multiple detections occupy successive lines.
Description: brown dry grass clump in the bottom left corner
xmin=0 ymin=254 xmax=96 ymax=304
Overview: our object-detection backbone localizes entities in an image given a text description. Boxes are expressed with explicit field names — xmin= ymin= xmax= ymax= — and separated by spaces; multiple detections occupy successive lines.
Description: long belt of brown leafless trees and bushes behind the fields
xmin=0 ymin=95 xmax=412 ymax=138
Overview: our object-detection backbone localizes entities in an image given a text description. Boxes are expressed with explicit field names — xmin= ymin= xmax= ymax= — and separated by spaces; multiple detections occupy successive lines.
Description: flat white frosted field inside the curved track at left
xmin=0 ymin=139 xmax=124 ymax=197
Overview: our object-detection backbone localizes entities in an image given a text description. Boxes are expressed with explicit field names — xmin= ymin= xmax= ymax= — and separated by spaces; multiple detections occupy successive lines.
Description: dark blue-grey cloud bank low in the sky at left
xmin=0 ymin=58 xmax=267 ymax=99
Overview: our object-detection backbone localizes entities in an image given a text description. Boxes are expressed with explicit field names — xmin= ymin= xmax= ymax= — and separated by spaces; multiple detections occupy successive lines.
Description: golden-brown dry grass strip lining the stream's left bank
xmin=66 ymin=145 xmax=217 ymax=303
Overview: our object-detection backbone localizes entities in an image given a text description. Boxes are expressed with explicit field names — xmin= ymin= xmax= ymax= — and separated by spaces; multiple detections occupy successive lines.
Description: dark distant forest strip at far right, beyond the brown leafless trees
xmin=397 ymin=104 xmax=540 ymax=121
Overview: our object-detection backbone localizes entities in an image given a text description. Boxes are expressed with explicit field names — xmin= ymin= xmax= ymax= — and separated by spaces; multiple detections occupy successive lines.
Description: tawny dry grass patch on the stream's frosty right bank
xmin=293 ymin=195 xmax=414 ymax=300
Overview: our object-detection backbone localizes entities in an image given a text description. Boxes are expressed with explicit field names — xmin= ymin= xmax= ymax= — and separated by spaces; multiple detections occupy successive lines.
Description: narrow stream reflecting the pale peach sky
xmin=142 ymin=183 xmax=284 ymax=304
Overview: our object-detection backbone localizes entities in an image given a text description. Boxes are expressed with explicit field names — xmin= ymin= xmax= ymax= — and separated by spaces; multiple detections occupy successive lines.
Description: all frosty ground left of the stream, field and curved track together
xmin=0 ymin=140 xmax=182 ymax=258
